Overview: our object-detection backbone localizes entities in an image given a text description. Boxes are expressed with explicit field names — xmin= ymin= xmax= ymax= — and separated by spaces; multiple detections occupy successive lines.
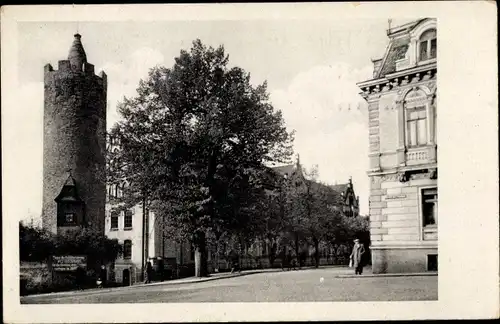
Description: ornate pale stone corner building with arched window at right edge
xmin=358 ymin=19 xmax=438 ymax=273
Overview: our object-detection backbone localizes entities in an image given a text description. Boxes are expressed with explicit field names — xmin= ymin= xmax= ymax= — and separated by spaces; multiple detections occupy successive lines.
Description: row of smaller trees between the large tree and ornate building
xmin=235 ymin=166 xmax=369 ymax=267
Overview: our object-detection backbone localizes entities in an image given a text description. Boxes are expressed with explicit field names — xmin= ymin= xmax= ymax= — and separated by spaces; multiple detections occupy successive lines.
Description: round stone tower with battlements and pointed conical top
xmin=42 ymin=34 xmax=107 ymax=234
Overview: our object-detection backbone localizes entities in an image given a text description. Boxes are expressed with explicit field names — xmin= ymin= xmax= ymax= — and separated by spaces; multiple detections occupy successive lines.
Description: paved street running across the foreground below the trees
xmin=21 ymin=268 xmax=438 ymax=304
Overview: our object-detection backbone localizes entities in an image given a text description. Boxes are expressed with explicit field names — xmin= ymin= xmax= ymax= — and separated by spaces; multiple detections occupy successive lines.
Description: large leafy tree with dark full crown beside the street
xmin=108 ymin=40 xmax=293 ymax=276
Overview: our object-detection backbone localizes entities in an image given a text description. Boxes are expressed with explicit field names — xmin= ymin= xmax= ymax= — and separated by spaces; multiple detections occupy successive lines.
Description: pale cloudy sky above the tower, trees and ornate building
xmin=13 ymin=19 xmax=416 ymax=224
